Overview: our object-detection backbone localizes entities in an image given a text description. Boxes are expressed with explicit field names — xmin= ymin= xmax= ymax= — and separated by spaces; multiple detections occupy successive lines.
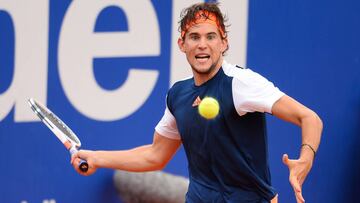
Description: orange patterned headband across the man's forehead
xmin=181 ymin=10 xmax=225 ymax=38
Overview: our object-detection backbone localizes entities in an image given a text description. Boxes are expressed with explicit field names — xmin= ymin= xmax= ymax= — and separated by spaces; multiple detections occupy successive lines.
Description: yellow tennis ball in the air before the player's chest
xmin=198 ymin=97 xmax=220 ymax=119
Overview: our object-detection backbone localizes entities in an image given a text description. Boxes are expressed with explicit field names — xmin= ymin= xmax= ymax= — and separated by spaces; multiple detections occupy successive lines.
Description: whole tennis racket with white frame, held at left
xmin=28 ymin=98 xmax=89 ymax=172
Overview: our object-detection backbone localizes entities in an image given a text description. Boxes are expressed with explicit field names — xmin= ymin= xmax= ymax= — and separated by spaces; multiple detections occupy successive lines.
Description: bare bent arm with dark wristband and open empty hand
xmin=271 ymin=95 xmax=323 ymax=203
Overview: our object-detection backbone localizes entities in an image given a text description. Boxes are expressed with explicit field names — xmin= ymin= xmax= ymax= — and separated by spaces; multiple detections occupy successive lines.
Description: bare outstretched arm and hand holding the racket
xmin=71 ymin=131 xmax=181 ymax=175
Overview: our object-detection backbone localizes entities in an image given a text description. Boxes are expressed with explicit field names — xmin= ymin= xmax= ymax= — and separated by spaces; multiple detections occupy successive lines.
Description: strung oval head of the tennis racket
xmin=28 ymin=98 xmax=81 ymax=148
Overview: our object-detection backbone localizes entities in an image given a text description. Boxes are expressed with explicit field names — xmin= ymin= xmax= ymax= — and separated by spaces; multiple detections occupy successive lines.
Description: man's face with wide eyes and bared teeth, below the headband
xmin=178 ymin=23 xmax=227 ymax=74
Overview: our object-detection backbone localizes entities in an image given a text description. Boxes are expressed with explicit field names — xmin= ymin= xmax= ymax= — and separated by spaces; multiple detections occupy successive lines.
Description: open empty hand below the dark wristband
xmin=282 ymin=154 xmax=312 ymax=203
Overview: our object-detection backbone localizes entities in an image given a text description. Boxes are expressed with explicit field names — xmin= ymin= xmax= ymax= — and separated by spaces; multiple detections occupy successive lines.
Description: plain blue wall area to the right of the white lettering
xmin=247 ymin=0 xmax=360 ymax=202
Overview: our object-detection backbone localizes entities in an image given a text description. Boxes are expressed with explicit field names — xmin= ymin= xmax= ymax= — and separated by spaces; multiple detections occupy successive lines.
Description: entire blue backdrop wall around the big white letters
xmin=0 ymin=0 xmax=360 ymax=203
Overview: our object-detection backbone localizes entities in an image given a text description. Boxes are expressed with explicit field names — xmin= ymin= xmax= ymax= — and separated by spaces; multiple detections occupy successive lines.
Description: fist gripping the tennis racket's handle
xmin=70 ymin=150 xmax=97 ymax=176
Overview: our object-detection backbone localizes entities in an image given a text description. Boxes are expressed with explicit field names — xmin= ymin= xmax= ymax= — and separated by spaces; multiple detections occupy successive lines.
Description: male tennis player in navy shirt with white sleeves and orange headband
xmin=72 ymin=3 xmax=322 ymax=203
